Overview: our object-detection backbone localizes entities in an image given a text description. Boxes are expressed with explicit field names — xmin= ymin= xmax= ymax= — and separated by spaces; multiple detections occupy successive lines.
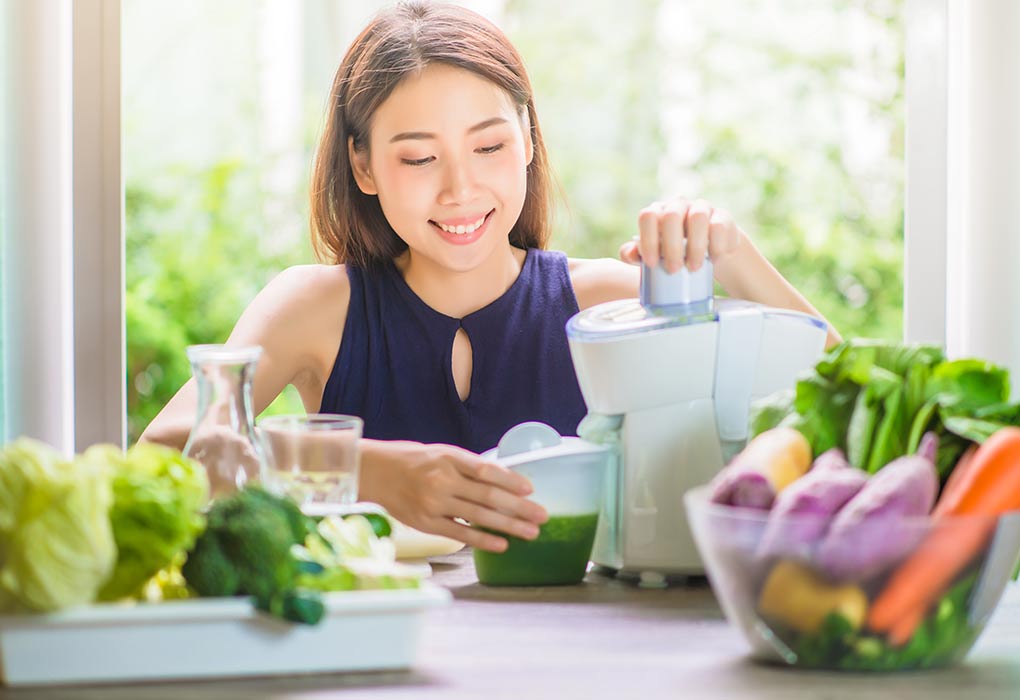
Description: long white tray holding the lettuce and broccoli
xmin=0 ymin=584 xmax=451 ymax=686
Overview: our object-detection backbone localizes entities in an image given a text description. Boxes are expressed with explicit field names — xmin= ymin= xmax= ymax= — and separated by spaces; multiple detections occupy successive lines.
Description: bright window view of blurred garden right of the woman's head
xmin=505 ymin=0 xmax=904 ymax=340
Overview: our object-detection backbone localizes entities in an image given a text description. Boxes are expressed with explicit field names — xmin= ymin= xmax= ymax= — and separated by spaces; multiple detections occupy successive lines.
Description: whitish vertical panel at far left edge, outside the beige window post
xmin=0 ymin=0 xmax=73 ymax=452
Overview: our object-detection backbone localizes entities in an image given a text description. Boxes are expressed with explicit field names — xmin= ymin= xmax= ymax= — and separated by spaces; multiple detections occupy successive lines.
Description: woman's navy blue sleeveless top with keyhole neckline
xmin=319 ymin=248 xmax=585 ymax=452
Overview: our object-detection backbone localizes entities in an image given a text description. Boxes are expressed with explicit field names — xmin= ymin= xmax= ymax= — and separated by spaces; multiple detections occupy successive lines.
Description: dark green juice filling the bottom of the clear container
xmin=474 ymin=512 xmax=599 ymax=586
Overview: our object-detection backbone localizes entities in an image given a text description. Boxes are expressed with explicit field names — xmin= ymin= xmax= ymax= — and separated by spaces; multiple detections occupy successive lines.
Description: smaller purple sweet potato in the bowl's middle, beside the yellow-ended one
xmin=758 ymin=448 xmax=868 ymax=559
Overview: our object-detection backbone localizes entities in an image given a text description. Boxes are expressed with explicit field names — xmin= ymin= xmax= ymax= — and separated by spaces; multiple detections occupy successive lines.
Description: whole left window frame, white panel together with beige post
xmin=0 ymin=0 xmax=125 ymax=454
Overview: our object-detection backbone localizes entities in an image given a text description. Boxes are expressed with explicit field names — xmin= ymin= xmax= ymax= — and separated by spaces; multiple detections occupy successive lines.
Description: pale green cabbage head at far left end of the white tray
xmin=0 ymin=438 xmax=116 ymax=612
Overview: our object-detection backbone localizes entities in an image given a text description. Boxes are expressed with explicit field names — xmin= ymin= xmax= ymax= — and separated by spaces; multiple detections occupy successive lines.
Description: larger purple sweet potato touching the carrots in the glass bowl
xmin=816 ymin=434 xmax=938 ymax=581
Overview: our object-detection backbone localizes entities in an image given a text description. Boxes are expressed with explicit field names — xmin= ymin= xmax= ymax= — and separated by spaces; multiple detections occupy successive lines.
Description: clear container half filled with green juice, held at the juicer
xmin=474 ymin=422 xmax=612 ymax=586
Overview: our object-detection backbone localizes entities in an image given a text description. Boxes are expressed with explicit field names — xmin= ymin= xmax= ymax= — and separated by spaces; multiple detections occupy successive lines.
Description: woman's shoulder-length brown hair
xmin=311 ymin=1 xmax=551 ymax=267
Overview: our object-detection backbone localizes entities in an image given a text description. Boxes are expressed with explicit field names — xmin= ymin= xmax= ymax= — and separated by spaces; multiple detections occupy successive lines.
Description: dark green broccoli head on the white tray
xmin=182 ymin=487 xmax=322 ymax=623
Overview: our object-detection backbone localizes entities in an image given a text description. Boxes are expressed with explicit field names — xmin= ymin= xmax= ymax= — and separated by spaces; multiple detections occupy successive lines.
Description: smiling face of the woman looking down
xmin=351 ymin=63 xmax=531 ymax=271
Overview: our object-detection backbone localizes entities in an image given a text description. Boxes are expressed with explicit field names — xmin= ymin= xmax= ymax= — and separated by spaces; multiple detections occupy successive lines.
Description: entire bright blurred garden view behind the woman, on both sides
xmin=122 ymin=0 xmax=904 ymax=443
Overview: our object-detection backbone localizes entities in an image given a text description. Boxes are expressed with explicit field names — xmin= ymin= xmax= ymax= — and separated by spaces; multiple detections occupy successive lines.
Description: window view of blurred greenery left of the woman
xmin=123 ymin=0 xmax=312 ymax=442
